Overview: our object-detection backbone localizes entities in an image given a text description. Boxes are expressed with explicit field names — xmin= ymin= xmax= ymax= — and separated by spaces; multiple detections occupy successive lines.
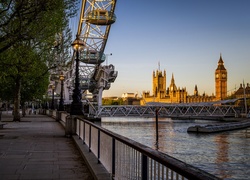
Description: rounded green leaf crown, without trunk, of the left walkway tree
xmin=0 ymin=42 xmax=49 ymax=101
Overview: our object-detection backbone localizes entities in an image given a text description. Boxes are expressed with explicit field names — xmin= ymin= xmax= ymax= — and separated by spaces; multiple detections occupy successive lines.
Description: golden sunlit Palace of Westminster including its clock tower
xmin=140 ymin=55 xmax=227 ymax=105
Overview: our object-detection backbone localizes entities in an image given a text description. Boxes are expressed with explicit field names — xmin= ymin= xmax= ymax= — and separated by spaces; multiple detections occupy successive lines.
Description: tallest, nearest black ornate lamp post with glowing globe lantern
xmin=70 ymin=36 xmax=84 ymax=115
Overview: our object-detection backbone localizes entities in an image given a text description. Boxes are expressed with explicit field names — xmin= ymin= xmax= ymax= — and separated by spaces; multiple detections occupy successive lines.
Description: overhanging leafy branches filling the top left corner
xmin=0 ymin=0 xmax=78 ymax=53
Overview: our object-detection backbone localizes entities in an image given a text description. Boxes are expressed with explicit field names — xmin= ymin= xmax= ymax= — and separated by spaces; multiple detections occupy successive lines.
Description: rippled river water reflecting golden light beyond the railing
xmin=101 ymin=117 xmax=250 ymax=180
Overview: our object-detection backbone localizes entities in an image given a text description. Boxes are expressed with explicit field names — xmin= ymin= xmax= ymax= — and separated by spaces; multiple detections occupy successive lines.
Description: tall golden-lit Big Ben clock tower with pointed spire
xmin=215 ymin=55 xmax=227 ymax=100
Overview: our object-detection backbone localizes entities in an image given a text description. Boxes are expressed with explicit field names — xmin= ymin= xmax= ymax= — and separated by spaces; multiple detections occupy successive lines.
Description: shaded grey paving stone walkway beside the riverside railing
xmin=0 ymin=113 xmax=94 ymax=180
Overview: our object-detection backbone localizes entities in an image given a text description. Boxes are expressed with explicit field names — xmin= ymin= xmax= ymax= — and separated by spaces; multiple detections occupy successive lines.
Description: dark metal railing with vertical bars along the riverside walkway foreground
xmin=73 ymin=117 xmax=219 ymax=180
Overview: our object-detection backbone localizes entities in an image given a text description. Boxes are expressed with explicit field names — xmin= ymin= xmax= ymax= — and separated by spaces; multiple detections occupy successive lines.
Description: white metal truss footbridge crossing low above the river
xmin=95 ymin=104 xmax=239 ymax=117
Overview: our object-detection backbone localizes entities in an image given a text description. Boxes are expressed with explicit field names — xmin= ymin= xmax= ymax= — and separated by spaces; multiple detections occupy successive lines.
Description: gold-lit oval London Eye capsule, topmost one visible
xmin=86 ymin=9 xmax=116 ymax=25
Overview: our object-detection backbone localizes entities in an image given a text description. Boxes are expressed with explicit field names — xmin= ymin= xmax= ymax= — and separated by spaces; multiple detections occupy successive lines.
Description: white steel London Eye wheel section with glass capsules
xmin=64 ymin=0 xmax=118 ymax=110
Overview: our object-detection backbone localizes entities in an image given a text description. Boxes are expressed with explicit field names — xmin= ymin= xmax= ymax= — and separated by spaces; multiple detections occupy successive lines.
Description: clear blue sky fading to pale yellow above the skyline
xmin=72 ymin=0 xmax=250 ymax=97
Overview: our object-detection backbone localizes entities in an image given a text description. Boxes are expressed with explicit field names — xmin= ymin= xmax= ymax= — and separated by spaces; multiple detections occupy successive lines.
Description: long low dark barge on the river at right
xmin=187 ymin=120 xmax=250 ymax=133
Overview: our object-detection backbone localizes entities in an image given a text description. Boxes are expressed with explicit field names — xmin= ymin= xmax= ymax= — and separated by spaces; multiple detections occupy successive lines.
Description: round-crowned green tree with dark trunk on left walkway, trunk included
xmin=0 ymin=45 xmax=48 ymax=121
